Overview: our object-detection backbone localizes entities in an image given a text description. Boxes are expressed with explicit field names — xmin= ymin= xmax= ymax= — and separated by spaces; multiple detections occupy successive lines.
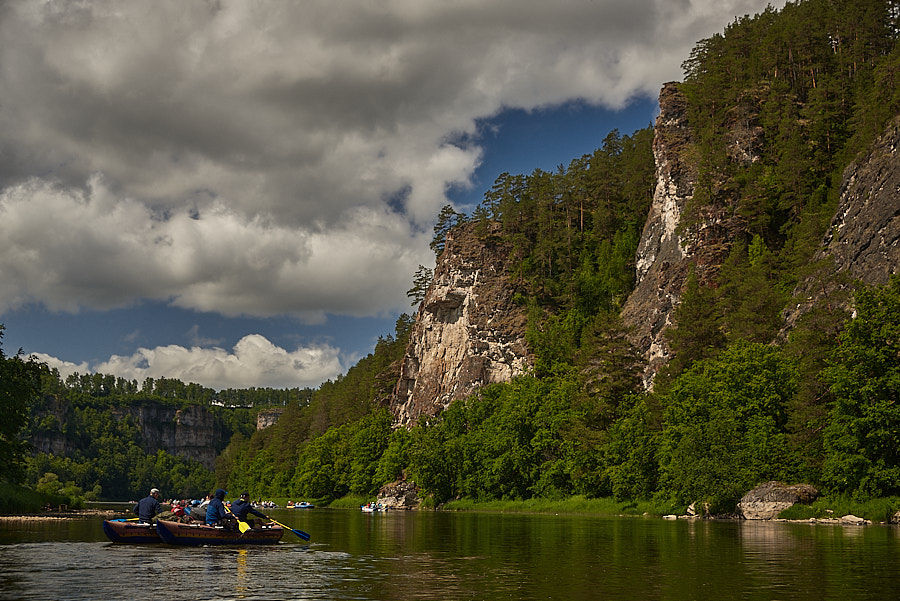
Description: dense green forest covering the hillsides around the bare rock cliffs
xmin=0 ymin=0 xmax=900 ymax=511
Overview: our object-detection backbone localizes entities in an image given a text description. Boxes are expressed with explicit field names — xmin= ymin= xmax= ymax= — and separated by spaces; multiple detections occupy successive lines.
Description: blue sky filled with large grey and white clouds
xmin=0 ymin=0 xmax=783 ymax=389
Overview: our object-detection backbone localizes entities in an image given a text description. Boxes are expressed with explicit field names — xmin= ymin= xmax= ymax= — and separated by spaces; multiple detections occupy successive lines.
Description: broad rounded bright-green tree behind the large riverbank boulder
xmin=659 ymin=341 xmax=797 ymax=508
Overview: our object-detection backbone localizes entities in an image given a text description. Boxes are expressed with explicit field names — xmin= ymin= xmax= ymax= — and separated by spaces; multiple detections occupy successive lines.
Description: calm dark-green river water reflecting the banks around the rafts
xmin=0 ymin=509 xmax=900 ymax=601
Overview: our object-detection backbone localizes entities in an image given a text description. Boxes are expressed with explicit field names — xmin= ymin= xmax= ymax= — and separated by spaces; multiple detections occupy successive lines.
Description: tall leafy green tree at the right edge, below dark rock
xmin=824 ymin=275 xmax=900 ymax=500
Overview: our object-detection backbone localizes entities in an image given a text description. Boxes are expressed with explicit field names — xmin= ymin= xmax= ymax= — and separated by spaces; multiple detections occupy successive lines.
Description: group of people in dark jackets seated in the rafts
xmin=134 ymin=488 xmax=269 ymax=529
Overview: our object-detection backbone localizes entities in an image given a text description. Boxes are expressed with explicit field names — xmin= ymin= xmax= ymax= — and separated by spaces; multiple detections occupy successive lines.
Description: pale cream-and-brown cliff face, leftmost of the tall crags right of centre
xmin=388 ymin=224 xmax=530 ymax=426
